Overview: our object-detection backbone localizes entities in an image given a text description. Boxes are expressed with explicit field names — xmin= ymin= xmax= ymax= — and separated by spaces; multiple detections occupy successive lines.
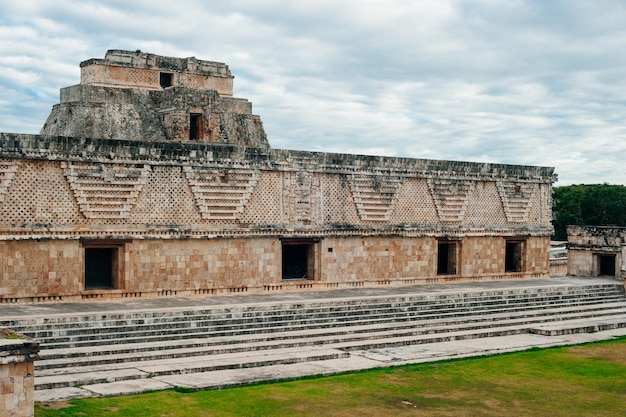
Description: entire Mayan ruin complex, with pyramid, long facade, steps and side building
xmin=0 ymin=50 xmax=626 ymax=410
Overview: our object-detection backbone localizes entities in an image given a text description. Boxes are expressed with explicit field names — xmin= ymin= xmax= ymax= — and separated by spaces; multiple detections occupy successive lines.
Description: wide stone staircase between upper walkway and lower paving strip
xmin=0 ymin=283 xmax=626 ymax=396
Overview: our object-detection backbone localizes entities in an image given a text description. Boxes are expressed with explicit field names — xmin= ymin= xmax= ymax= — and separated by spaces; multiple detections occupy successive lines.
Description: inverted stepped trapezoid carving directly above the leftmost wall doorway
xmin=61 ymin=162 xmax=150 ymax=219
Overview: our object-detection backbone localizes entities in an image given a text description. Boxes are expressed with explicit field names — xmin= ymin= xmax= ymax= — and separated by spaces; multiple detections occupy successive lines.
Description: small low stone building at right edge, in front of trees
xmin=567 ymin=226 xmax=626 ymax=279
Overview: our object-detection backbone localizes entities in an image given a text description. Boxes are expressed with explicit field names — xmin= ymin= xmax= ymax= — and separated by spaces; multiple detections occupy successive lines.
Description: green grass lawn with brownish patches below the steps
xmin=35 ymin=338 xmax=626 ymax=417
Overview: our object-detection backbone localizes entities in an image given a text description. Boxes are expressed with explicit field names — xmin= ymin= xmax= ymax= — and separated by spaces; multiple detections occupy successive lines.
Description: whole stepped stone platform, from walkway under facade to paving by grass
xmin=0 ymin=277 xmax=626 ymax=401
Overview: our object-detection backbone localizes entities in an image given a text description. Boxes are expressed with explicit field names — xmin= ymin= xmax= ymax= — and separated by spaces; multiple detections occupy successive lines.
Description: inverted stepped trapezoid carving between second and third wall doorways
xmin=350 ymin=175 xmax=404 ymax=221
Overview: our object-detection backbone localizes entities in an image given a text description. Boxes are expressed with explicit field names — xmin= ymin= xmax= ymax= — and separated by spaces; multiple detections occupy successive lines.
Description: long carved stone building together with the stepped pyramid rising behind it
xmin=0 ymin=51 xmax=555 ymax=302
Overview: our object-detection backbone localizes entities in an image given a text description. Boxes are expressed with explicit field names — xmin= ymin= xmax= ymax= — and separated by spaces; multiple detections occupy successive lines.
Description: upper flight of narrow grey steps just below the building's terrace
xmin=8 ymin=289 xmax=623 ymax=343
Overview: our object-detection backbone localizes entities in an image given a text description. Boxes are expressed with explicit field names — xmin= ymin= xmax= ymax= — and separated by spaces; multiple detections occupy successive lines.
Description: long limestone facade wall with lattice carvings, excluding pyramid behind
xmin=0 ymin=134 xmax=554 ymax=302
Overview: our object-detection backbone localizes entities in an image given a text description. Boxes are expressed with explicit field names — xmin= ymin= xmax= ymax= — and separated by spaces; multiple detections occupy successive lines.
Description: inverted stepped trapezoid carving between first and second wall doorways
xmin=184 ymin=167 xmax=259 ymax=220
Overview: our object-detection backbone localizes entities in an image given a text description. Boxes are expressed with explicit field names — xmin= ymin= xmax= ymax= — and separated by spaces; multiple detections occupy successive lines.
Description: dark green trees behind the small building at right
xmin=552 ymin=184 xmax=626 ymax=240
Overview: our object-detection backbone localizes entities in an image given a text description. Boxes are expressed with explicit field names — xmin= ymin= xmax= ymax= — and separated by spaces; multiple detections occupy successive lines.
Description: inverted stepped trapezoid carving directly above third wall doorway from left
xmin=428 ymin=178 xmax=475 ymax=222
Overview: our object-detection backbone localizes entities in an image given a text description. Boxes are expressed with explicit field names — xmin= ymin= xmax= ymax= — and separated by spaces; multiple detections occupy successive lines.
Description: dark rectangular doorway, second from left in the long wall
xmin=282 ymin=240 xmax=318 ymax=280
